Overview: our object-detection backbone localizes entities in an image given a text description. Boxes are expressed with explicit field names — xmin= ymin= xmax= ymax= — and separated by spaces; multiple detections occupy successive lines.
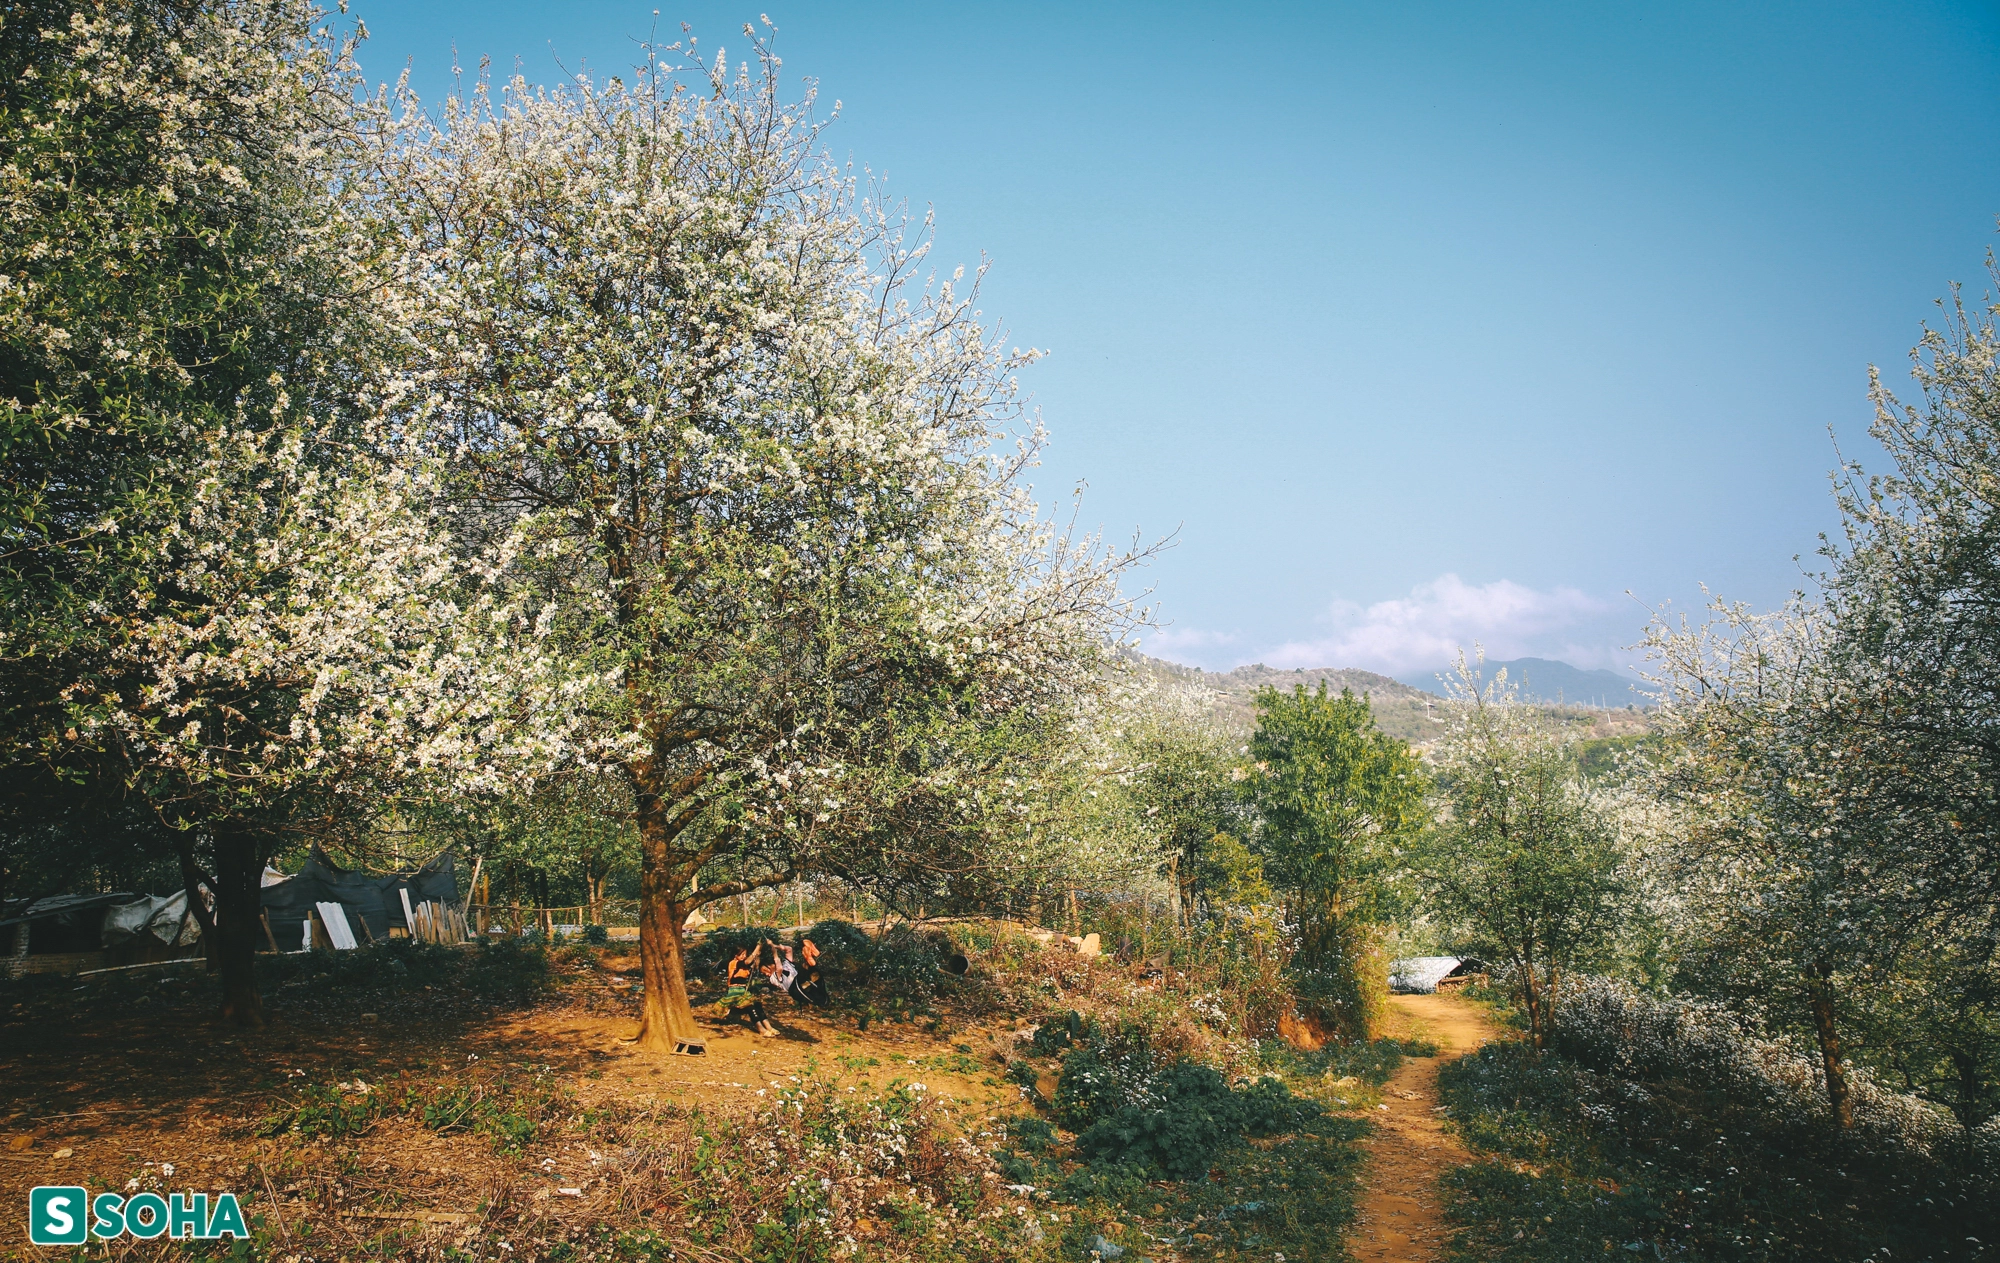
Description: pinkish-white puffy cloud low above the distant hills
xmin=1262 ymin=574 xmax=1610 ymax=675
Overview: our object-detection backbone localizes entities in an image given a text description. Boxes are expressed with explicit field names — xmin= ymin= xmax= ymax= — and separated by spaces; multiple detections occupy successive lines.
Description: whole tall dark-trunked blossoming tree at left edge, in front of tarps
xmin=0 ymin=0 xmax=572 ymax=1023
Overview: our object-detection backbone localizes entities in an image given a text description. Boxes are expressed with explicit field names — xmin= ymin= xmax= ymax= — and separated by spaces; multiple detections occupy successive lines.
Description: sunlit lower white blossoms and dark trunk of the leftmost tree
xmin=60 ymin=426 xmax=566 ymax=1023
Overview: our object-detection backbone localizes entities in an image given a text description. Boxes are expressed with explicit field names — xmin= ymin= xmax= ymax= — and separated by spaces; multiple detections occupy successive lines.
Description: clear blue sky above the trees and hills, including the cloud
xmin=356 ymin=0 xmax=2000 ymax=673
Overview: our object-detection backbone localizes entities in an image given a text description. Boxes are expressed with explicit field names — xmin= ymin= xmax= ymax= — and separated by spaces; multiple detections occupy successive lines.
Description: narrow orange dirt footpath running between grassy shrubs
xmin=1348 ymin=995 xmax=1496 ymax=1263
